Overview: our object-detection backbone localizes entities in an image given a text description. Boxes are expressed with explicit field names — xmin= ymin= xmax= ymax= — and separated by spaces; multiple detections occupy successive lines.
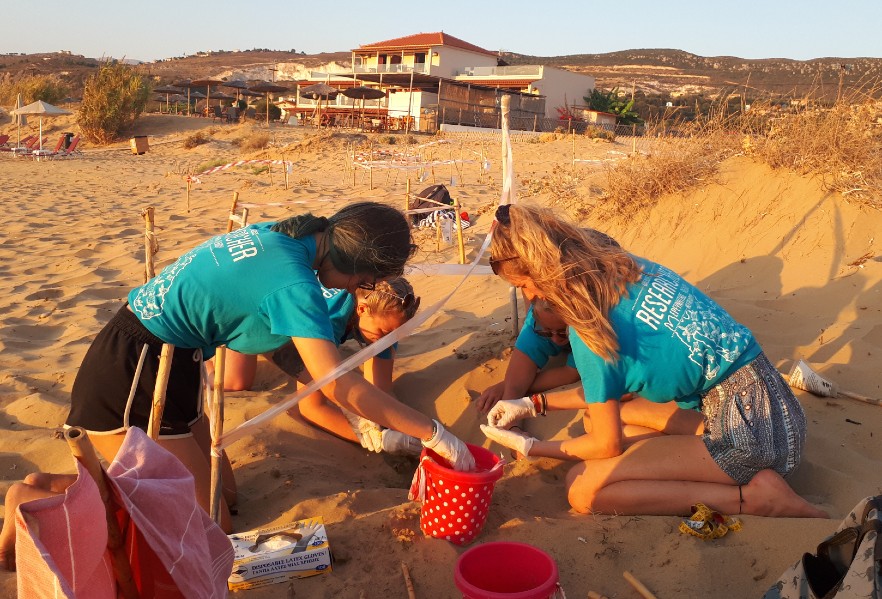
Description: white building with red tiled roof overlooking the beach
xmin=286 ymin=32 xmax=594 ymax=132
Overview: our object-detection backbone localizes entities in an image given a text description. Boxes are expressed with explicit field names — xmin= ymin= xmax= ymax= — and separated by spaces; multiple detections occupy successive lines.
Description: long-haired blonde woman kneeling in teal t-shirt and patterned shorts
xmin=481 ymin=206 xmax=826 ymax=517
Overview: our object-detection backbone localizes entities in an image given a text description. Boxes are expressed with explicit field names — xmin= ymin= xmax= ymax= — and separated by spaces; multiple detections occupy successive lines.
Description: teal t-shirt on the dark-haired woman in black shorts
xmin=128 ymin=223 xmax=336 ymax=359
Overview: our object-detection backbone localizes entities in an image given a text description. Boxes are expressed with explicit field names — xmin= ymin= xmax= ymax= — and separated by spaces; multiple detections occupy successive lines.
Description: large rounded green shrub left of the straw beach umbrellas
xmin=77 ymin=62 xmax=150 ymax=144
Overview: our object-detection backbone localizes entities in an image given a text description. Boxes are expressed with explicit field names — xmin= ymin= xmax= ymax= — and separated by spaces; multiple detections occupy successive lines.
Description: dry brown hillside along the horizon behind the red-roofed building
xmin=0 ymin=49 xmax=882 ymax=100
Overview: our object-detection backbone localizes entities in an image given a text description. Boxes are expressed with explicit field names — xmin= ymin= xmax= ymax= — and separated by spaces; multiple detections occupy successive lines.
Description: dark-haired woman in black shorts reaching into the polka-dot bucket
xmin=66 ymin=202 xmax=474 ymax=530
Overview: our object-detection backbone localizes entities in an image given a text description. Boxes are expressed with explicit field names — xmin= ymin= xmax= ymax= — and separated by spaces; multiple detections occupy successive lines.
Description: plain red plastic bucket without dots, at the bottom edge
xmin=453 ymin=541 xmax=558 ymax=599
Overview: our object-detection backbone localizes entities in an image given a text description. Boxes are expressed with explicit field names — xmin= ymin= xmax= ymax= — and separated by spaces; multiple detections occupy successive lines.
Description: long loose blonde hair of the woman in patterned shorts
xmin=490 ymin=205 xmax=643 ymax=361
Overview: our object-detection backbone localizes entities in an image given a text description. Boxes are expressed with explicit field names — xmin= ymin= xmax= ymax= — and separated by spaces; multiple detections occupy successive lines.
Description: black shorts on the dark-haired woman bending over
xmin=65 ymin=304 xmax=202 ymax=436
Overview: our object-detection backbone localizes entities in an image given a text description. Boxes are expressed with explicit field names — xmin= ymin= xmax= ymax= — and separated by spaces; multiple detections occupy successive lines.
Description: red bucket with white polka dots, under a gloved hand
xmin=409 ymin=443 xmax=505 ymax=545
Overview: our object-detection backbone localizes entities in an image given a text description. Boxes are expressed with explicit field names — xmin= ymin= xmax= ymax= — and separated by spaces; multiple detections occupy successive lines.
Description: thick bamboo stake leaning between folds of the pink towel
xmin=64 ymin=426 xmax=138 ymax=599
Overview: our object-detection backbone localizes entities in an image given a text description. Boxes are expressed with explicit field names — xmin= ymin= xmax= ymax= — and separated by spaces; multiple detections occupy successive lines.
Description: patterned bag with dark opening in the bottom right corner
xmin=763 ymin=495 xmax=882 ymax=599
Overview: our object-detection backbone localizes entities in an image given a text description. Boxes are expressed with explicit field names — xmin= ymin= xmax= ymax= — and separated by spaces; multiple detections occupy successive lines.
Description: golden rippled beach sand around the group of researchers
xmin=0 ymin=115 xmax=882 ymax=599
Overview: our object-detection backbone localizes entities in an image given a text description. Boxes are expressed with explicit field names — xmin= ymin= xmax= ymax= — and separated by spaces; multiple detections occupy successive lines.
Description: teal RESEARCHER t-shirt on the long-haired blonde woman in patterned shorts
xmin=570 ymin=257 xmax=761 ymax=409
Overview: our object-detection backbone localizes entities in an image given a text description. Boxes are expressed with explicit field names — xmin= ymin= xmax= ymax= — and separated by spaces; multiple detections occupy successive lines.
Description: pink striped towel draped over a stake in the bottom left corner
xmin=15 ymin=428 xmax=233 ymax=599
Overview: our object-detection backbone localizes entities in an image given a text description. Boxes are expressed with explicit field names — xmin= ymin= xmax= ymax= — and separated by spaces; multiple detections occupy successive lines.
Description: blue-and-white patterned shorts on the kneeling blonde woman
xmin=701 ymin=354 xmax=806 ymax=484
